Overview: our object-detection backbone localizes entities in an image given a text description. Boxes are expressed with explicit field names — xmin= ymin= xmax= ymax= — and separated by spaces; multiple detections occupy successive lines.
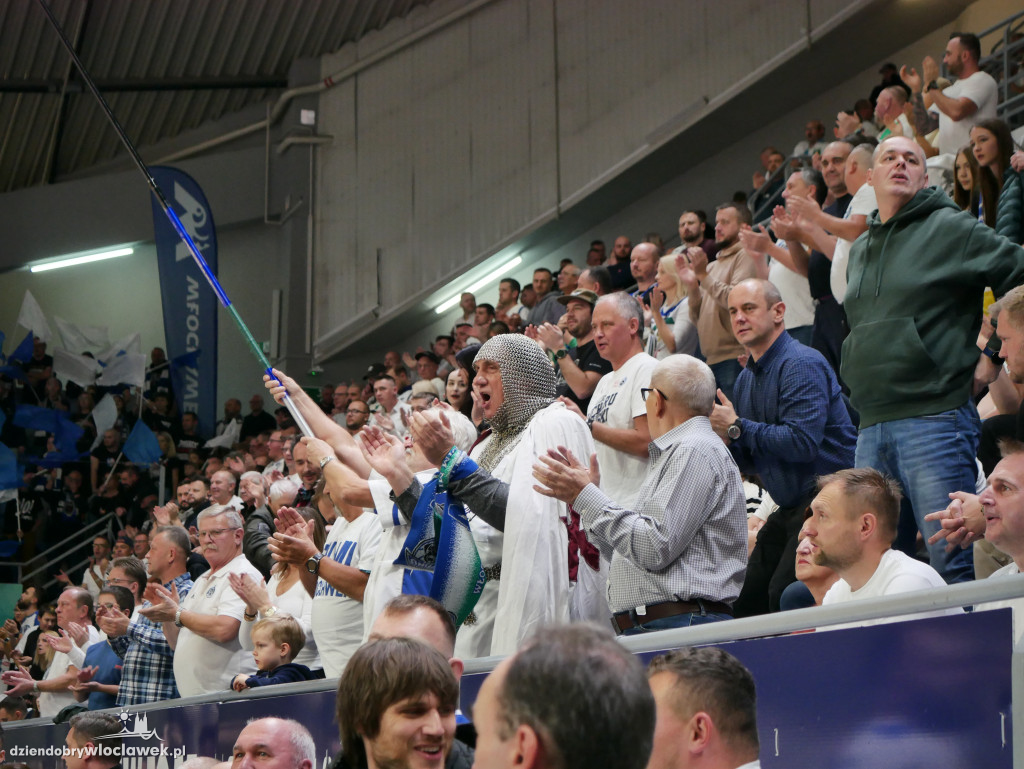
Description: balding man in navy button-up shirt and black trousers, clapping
xmin=711 ymin=279 xmax=857 ymax=616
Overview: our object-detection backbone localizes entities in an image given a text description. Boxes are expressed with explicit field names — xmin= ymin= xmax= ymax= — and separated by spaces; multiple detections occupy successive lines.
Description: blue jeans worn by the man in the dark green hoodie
xmin=855 ymin=401 xmax=981 ymax=583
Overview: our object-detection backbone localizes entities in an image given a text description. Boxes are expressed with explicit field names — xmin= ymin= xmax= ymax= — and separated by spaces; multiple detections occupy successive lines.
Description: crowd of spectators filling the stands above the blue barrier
xmin=0 ymin=33 xmax=1024 ymax=751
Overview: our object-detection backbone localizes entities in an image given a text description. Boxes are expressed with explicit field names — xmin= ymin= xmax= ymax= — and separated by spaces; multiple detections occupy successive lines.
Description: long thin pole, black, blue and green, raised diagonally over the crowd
xmin=37 ymin=0 xmax=313 ymax=437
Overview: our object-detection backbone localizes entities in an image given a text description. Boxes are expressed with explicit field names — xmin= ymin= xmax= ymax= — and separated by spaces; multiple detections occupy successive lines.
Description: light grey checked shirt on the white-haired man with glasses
xmin=572 ymin=417 xmax=746 ymax=612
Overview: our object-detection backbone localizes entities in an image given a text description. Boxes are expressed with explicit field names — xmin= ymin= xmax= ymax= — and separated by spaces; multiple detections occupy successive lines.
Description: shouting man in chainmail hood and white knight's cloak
xmin=382 ymin=334 xmax=594 ymax=657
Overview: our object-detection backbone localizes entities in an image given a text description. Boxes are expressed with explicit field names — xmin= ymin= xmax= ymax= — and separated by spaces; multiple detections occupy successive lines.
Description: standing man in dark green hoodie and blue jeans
xmin=843 ymin=136 xmax=1024 ymax=582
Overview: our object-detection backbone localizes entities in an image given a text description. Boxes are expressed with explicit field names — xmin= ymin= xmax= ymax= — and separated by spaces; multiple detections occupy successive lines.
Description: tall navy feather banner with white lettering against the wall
xmin=150 ymin=166 xmax=217 ymax=432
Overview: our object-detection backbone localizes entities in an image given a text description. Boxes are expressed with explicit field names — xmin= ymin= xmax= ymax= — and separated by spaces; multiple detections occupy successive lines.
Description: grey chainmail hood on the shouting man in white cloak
xmin=474 ymin=334 xmax=555 ymax=471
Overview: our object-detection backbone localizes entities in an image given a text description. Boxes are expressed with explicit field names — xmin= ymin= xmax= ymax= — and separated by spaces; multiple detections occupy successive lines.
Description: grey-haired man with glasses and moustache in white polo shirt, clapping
xmin=141 ymin=505 xmax=262 ymax=697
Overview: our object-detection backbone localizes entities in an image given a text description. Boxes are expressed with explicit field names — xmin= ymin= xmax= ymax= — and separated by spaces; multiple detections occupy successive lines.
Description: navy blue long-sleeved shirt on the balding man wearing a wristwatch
xmin=729 ymin=331 xmax=857 ymax=507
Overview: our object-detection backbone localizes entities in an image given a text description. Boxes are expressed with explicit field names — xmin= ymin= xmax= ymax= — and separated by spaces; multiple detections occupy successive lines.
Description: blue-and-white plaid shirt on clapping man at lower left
xmin=108 ymin=571 xmax=193 ymax=708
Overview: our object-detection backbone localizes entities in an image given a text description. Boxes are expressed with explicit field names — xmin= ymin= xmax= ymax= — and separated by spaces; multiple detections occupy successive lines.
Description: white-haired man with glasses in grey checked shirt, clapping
xmin=534 ymin=355 xmax=746 ymax=635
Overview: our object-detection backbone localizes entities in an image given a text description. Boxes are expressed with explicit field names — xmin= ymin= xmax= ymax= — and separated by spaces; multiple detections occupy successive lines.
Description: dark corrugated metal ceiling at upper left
xmin=0 ymin=0 xmax=429 ymax=191
